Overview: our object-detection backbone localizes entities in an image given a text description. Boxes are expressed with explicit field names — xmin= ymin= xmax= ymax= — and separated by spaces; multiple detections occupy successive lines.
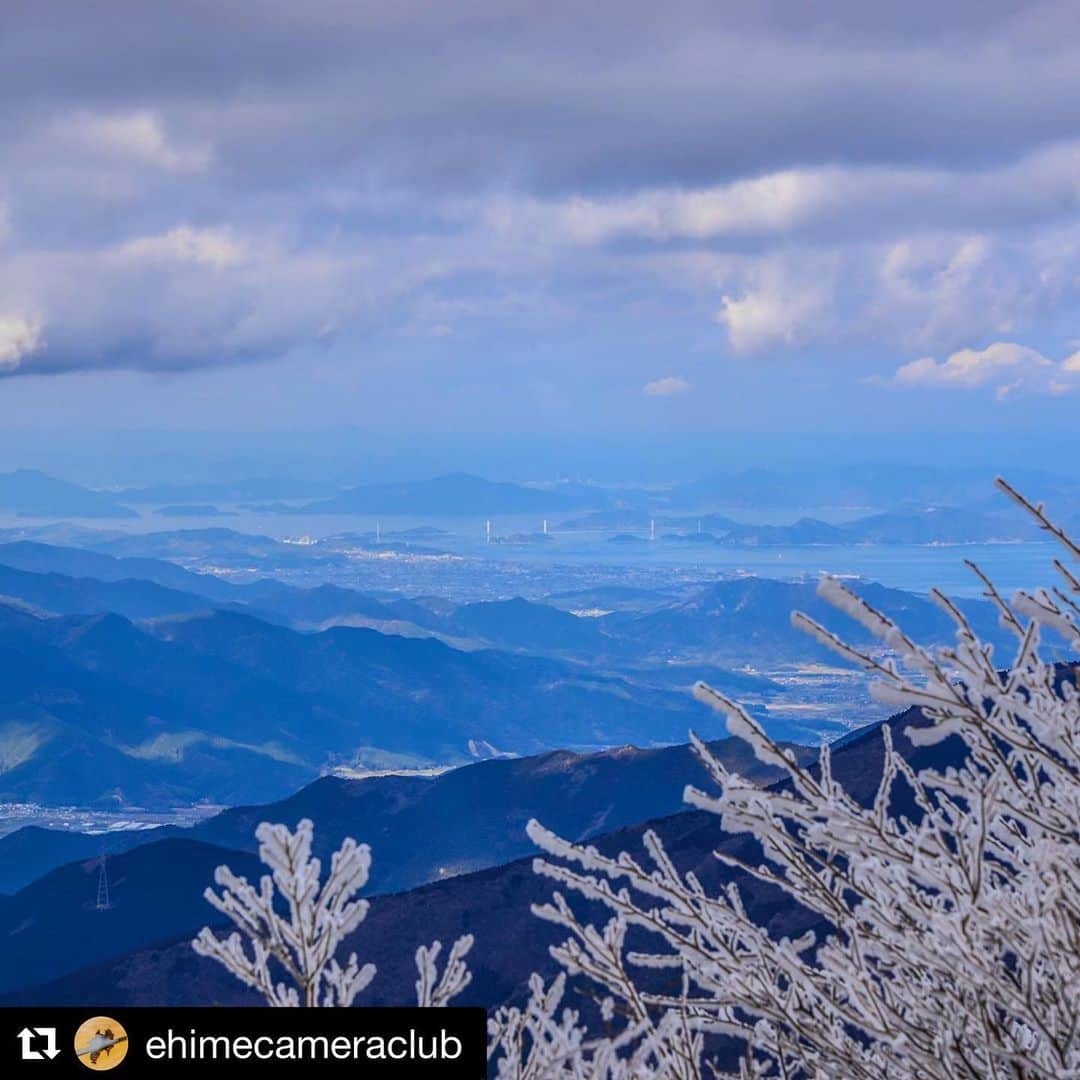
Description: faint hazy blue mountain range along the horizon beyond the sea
xmin=0 ymin=464 xmax=1077 ymax=529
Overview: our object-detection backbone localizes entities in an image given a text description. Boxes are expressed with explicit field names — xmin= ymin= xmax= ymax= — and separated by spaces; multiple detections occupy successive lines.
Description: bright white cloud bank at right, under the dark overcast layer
xmin=474 ymin=141 xmax=1080 ymax=354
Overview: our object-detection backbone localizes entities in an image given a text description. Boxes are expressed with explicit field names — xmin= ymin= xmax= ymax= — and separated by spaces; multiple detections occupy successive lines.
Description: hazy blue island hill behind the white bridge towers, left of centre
xmin=298 ymin=473 xmax=603 ymax=517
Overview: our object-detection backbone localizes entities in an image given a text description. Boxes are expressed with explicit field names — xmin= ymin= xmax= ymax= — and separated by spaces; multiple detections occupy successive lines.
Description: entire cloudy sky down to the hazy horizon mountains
xmin=0 ymin=0 xmax=1080 ymax=473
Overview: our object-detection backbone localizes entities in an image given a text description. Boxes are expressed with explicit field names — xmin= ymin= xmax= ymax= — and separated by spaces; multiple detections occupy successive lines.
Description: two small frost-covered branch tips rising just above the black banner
xmin=192 ymin=819 xmax=473 ymax=1007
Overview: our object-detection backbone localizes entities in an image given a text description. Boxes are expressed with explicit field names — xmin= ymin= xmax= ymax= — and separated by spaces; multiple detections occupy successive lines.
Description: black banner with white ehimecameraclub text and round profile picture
xmin=0 ymin=1007 xmax=487 ymax=1080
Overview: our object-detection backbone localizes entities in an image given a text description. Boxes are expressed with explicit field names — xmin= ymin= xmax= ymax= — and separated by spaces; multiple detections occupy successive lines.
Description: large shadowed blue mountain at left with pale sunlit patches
xmin=0 ymin=606 xmax=717 ymax=806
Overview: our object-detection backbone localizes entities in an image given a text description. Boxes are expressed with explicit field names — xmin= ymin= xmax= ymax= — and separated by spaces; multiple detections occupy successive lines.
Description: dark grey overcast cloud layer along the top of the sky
xmin=2 ymin=0 xmax=1080 ymax=190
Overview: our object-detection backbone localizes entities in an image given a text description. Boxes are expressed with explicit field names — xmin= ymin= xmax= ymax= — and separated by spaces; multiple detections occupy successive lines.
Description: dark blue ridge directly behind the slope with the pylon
xmin=0 ymin=739 xmax=816 ymax=893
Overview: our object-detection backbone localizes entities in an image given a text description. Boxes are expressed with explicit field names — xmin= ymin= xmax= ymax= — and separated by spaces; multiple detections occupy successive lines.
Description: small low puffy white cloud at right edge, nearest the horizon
xmin=892 ymin=341 xmax=1080 ymax=401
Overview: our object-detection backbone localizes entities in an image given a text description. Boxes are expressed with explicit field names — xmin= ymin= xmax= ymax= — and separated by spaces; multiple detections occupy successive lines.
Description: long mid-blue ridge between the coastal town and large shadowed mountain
xmin=0 ymin=542 xmax=1019 ymax=681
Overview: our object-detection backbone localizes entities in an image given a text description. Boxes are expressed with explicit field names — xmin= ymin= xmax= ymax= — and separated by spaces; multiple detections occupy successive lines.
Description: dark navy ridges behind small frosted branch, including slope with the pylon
xmin=0 ymin=739 xmax=813 ymax=994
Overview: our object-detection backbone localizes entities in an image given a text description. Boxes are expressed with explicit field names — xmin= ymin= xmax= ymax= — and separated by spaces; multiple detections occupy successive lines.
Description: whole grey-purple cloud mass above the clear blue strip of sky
xmin=0 ymin=0 xmax=1080 ymax=380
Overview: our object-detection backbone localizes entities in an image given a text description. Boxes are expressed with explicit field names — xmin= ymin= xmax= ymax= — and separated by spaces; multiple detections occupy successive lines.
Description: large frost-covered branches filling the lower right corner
xmin=489 ymin=482 xmax=1080 ymax=1080
